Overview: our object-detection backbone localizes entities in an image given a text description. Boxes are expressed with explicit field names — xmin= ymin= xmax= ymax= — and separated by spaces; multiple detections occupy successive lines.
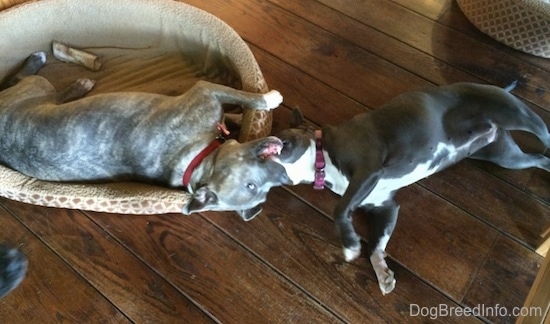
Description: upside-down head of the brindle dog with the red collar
xmin=183 ymin=136 xmax=289 ymax=221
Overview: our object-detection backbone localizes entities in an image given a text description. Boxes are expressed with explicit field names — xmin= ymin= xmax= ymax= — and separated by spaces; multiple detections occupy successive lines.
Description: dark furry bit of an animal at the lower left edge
xmin=0 ymin=244 xmax=27 ymax=298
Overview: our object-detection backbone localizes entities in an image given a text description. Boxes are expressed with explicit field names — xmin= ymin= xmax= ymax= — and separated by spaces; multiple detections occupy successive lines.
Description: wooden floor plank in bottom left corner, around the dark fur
xmin=0 ymin=202 xmax=130 ymax=323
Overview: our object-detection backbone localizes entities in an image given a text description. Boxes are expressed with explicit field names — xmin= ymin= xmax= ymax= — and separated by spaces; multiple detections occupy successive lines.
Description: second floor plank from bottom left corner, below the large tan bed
xmin=3 ymin=201 xmax=211 ymax=323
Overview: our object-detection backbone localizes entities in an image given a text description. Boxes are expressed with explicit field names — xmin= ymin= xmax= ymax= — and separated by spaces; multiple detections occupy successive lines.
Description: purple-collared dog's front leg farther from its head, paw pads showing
xmin=365 ymin=200 xmax=399 ymax=295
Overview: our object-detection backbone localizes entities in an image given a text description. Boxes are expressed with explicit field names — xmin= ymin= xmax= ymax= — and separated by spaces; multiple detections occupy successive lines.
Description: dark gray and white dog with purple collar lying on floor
xmin=274 ymin=83 xmax=550 ymax=294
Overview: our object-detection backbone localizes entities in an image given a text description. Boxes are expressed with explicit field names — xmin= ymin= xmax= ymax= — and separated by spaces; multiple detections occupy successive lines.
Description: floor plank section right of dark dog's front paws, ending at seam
xmin=388 ymin=186 xmax=500 ymax=301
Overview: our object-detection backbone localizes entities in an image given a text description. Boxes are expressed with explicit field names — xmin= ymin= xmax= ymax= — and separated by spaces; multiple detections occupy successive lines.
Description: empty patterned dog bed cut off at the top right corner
xmin=457 ymin=0 xmax=550 ymax=58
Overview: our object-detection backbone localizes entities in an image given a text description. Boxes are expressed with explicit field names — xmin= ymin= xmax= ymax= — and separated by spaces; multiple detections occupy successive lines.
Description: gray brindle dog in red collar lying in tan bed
xmin=0 ymin=52 xmax=286 ymax=220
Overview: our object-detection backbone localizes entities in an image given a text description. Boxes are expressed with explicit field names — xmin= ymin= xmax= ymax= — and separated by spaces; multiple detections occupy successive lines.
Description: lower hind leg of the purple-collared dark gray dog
xmin=470 ymin=128 xmax=550 ymax=172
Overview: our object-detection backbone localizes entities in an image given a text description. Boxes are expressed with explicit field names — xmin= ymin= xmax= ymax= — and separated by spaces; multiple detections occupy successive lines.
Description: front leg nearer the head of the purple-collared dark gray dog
xmin=334 ymin=174 xmax=378 ymax=262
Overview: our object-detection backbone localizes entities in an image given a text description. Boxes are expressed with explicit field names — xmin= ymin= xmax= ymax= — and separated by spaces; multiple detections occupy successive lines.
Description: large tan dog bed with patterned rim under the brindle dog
xmin=0 ymin=0 xmax=272 ymax=214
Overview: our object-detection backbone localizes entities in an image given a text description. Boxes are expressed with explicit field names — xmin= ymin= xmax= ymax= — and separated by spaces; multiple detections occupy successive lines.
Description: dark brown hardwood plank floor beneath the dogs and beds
xmin=0 ymin=0 xmax=550 ymax=323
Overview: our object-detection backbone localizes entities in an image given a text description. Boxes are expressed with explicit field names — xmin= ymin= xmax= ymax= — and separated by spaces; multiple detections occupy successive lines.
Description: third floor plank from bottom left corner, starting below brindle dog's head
xmin=90 ymin=213 xmax=340 ymax=323
